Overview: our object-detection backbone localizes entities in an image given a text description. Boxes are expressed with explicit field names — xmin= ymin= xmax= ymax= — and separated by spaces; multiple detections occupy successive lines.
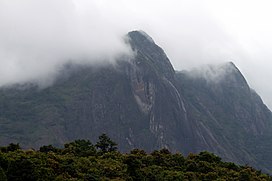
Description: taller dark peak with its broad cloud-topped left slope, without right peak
xmin=0 ymin=32 xmax=193 ymax=151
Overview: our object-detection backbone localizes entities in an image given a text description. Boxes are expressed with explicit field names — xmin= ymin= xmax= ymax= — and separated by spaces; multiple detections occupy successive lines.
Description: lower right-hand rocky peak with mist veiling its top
xmin=177 ymin=62 xmax=271 ymax=171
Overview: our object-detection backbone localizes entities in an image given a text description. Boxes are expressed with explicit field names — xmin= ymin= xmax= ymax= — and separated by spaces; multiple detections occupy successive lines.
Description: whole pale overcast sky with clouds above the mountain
xmin=0 ymin=0 xmax=272 ymax=108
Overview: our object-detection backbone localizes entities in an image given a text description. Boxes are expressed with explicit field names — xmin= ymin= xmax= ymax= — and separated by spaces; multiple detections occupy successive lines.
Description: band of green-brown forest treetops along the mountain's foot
xmin=0 ymin=134 xmax=272 ymax=181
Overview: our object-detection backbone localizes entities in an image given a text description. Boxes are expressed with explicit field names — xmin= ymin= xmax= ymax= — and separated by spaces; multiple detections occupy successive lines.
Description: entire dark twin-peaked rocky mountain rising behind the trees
xmin=0 ymin=31 xmax=272 ymax=172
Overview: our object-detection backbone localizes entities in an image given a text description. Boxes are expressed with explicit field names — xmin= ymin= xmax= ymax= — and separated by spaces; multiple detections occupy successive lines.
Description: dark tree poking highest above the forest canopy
xmin=95 ymin=133 xmax=117 ymax=153
